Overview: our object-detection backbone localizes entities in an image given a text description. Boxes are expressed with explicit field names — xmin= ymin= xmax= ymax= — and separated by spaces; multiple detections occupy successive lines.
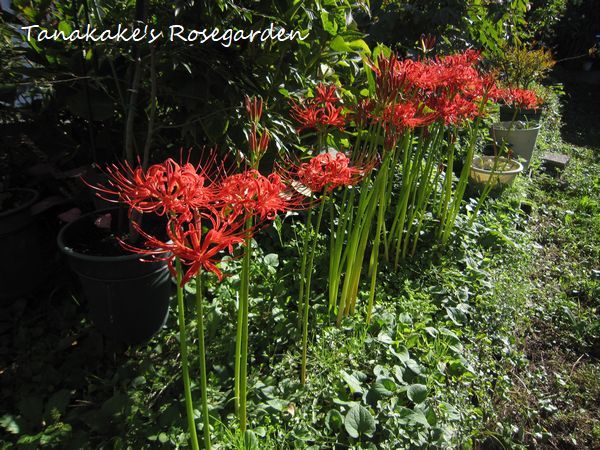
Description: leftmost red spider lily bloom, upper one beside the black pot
xmin=84 ymin=158 xmax=214 ymax=221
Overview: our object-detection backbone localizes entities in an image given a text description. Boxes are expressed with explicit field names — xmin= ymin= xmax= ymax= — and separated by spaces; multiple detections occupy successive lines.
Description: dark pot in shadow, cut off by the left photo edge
xmin=0 ymin=189 xmax=44 ymax=300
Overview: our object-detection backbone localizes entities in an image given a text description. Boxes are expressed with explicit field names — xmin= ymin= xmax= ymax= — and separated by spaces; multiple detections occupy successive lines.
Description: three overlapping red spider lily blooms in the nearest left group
xmin=86 ymin=158 xmax=299 ymax=284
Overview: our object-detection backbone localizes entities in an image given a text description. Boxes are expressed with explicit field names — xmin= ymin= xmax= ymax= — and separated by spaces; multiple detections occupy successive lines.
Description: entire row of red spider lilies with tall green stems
xmin=89 ymin=50 xmax=539 ymax=448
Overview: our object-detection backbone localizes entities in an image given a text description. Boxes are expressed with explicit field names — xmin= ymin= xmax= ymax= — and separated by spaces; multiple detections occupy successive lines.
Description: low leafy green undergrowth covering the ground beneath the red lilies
xmin=0 ymin=80 xmax=600 ymax=449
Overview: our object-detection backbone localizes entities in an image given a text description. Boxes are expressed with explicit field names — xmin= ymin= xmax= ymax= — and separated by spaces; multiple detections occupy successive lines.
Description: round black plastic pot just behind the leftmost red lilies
xmin=57 ymin=210 xmax=172 ymax=344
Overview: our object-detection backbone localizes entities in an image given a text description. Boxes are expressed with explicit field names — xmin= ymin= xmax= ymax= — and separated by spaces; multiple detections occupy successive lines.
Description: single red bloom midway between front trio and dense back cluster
xmin=296 ymin=152 xmax=369 ymax=193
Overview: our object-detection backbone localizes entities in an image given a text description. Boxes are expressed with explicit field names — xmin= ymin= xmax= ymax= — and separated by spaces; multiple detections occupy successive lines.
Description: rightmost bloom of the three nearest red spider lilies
xmin=216 ymin=169 xmax=298 ymax=220
